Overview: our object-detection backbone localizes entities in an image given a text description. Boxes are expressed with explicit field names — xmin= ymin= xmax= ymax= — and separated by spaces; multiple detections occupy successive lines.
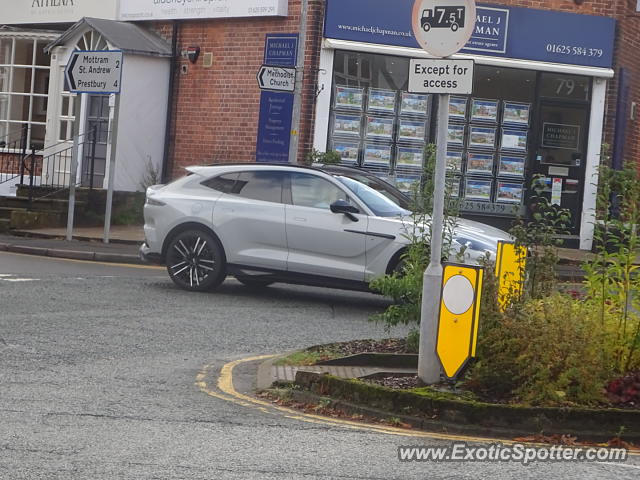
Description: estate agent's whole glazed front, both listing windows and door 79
xmin=328 ymin=51 xmax=590 ymax=226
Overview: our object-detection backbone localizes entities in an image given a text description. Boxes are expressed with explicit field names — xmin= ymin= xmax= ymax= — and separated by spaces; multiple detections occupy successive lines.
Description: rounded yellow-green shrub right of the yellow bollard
xmin=466 ymin=293 xmax=611 ymax=405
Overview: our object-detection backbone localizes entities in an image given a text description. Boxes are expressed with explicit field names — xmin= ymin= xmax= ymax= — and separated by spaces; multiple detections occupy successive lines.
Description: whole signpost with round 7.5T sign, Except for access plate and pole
xmin=410 ymin=0 xmax=476 ymax=384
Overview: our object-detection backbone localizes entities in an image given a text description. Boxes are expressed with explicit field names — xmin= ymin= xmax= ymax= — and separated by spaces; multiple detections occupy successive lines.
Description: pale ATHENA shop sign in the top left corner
xmin=0 ymin=0 xmax=118 ymax=25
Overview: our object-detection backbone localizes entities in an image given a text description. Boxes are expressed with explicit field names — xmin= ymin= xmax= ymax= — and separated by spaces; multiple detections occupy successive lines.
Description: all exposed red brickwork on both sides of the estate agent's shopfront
xmin=155 ymin=0 xmax=640 ymax=177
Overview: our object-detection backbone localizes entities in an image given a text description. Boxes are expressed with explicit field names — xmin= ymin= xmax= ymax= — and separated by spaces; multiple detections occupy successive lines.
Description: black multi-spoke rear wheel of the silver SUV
xmin=166 ymin=229 xmax=226 ymax=292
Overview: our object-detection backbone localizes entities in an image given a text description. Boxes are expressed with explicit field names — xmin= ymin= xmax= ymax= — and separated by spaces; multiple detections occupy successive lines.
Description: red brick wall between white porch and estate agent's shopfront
xmin=150 ymin=0 xmax=324 ymax=177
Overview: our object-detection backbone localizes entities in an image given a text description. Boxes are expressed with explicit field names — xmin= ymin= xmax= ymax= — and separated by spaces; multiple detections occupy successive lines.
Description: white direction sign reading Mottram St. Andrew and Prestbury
xmin=64 ymin=50 xmax=122 ymax=94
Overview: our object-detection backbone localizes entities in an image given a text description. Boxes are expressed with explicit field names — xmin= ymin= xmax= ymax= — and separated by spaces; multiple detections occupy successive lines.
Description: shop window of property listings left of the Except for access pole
xmin=328 ymin=51 xmax=431 ymax=185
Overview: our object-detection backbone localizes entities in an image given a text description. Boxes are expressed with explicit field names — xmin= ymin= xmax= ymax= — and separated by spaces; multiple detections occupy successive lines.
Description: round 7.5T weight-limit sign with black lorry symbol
xmin=411 ymin=0 xmax=476 ymax=57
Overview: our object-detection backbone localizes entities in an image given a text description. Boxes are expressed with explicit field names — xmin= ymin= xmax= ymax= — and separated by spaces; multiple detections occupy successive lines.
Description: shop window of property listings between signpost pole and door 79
xmin=447 ymin=65 xmax=537 ymax=216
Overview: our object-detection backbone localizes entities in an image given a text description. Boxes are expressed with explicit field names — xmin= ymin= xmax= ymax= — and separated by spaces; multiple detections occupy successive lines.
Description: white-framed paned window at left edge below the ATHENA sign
xmin=0 ymin=36 xmax=50 ymax=149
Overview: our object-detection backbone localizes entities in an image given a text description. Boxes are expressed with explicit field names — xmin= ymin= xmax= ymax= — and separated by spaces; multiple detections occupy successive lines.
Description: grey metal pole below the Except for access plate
xmin=418 ymin=94 xmax=450 ymax=384
